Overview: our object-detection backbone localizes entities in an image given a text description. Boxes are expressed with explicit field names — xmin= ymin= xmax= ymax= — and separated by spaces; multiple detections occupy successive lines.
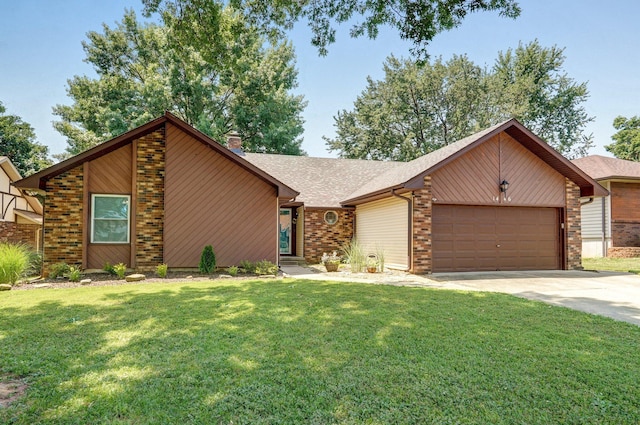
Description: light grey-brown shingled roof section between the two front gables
xmin=243 ymin=153 xmax=398 ymax=208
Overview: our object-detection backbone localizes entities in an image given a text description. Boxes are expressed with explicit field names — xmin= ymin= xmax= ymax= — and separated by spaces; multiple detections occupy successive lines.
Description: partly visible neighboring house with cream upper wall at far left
xmin=0 ymin=156 xmax=42 ymax=250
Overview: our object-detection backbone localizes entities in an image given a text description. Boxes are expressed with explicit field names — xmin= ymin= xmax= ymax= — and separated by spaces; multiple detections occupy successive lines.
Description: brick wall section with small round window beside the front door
xmin=304 ymin=209 xmax=354 ymax=264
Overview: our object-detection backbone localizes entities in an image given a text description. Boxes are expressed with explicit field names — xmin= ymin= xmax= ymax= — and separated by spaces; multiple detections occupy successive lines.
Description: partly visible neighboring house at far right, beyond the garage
xmin=572 ymin=155 xmax=640 ymax=257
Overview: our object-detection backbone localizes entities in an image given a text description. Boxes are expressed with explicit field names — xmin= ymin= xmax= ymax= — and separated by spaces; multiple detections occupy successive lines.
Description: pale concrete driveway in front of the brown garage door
xmin=430 ymin=271 xmax=640 ymax=325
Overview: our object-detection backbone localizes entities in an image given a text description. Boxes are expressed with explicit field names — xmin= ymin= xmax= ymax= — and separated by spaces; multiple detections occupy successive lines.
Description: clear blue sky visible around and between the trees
xmin=0 ymin=0 xmax=640 ymax=157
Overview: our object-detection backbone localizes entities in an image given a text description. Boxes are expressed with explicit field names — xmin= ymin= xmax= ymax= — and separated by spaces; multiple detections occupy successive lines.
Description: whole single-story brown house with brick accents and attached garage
xmin=18 ymin=113 xmax=607 ymax=273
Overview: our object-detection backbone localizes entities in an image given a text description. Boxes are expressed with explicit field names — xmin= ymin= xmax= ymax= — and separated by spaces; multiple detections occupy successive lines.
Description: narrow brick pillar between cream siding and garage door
xmin=411 ymin=176 xmax=433 ymax=274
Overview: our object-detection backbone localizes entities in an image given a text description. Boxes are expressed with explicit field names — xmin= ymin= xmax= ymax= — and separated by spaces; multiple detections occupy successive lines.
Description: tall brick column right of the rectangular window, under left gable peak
xmin=134 ymin=129 xmax=165 ymax=271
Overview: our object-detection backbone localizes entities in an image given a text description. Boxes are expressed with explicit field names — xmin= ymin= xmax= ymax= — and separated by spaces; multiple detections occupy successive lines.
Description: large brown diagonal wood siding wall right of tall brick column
xmin=164 ymin=125 xmax=279 ymax=267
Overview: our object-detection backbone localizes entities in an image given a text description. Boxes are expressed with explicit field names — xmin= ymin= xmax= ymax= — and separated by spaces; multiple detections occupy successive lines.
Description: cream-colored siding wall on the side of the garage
xmin=356 ymin=198 xmax=409 ymax=269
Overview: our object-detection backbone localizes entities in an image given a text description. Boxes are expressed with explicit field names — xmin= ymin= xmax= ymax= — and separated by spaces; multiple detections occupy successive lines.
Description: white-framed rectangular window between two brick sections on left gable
xmin=91 ymin=195 xmax=131 ymax=243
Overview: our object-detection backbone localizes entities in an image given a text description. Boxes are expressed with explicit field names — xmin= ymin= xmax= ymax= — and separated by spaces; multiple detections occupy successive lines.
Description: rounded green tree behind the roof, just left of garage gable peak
xmin=325 ymin=56 xmax=490 ymax=161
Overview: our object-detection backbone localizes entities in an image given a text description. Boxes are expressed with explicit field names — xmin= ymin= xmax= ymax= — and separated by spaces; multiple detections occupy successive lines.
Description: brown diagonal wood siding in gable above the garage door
xmin=432 ymin=133 xmax=565 ymax=207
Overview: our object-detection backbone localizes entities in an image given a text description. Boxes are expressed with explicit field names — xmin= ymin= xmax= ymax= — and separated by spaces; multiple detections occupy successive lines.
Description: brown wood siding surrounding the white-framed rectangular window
xmin=85 ymin=144 xmax=133 ymax=269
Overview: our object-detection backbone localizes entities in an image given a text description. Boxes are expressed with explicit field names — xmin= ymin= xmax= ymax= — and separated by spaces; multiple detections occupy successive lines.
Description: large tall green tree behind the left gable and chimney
xmin=54 ymin=8 xmax=305 ymax=159
